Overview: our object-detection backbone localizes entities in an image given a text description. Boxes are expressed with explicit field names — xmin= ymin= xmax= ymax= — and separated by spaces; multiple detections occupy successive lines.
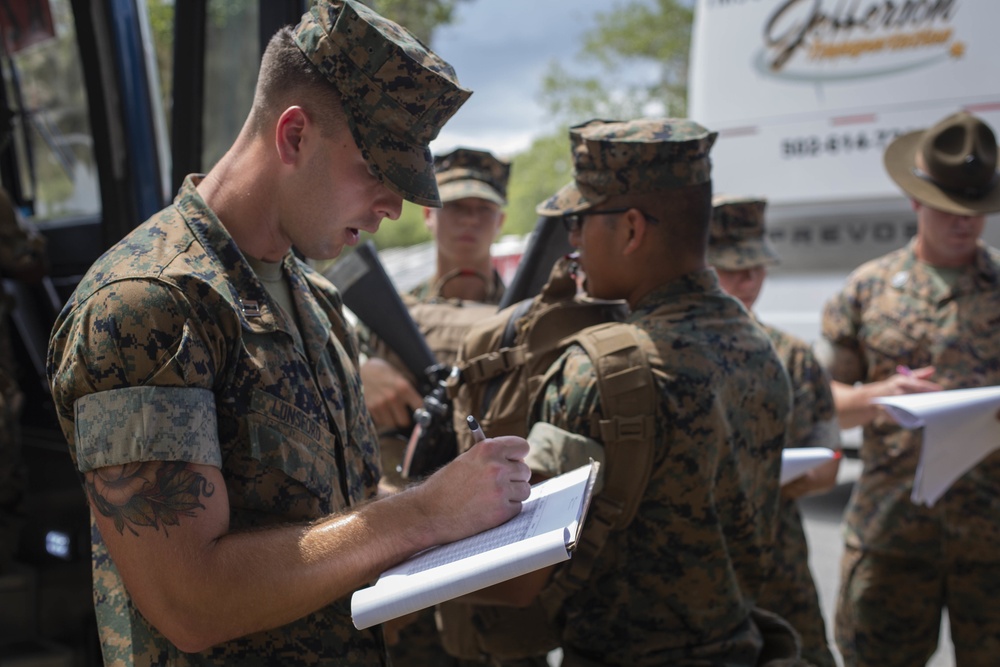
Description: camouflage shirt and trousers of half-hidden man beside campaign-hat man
xmin=757 ymin=323 xmax=840 ymax=667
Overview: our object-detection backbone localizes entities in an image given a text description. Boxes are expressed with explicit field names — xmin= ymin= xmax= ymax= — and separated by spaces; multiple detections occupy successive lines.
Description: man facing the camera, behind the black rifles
xmin=359 ymin=148 xmax=510 ymax=667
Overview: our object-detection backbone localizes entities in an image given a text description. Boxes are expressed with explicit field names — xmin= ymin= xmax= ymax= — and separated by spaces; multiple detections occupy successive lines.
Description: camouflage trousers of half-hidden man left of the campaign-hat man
xmin=757 ymin=498 xmax=837 ymax=667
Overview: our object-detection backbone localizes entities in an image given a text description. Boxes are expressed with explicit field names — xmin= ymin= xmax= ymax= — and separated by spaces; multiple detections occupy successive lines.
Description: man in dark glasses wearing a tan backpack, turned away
xmin=470 ymin=119 xmax=798 ymax=667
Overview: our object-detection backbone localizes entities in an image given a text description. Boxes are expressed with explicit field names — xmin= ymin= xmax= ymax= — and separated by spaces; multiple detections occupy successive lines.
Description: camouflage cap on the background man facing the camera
xmin=434 ymin=148 xmax=510 ymax=206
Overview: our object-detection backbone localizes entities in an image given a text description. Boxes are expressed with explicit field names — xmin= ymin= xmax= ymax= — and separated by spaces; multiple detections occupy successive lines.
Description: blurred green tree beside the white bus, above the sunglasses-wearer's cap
xmin=540 ymin=0 xmax=694 ymax=123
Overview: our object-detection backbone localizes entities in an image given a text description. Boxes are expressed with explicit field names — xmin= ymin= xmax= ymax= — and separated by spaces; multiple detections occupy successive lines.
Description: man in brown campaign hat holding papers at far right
xmin=823 ymin=112 xmax=1000 ymax=667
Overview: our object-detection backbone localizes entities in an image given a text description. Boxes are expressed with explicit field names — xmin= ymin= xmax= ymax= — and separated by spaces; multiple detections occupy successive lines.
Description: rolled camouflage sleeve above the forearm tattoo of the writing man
xmin=48 ymin=279 xmax=227 ymax=471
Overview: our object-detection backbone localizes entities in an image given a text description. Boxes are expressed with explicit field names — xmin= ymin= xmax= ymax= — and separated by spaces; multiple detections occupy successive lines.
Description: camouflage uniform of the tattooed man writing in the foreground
xmin=48 ymin=177 xmax=385 ymax=666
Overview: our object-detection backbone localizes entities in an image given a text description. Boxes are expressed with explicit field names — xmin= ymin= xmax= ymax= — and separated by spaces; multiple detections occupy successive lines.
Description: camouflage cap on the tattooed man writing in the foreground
xmin=292 ymin=0 xmax=472 ymax=207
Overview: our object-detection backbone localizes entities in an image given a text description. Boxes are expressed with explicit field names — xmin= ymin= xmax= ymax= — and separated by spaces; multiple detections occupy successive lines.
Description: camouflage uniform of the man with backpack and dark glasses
xmin=533 ymin=270 xmax=791 ymax=667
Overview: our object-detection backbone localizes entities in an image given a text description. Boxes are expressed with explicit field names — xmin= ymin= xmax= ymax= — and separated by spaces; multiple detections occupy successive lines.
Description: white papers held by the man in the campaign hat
xmin=875 ymin=387 xmax=1000 ymax=506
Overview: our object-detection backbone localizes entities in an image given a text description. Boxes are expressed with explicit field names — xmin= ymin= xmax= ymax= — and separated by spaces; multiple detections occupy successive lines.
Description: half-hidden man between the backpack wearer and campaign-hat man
xmin=708 ymin=195 xmax=840 ymax=667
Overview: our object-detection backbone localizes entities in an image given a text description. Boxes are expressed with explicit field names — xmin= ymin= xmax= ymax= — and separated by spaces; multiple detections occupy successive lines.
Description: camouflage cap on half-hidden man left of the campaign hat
xmin=708 ymin=195 xmax=778 ymax=271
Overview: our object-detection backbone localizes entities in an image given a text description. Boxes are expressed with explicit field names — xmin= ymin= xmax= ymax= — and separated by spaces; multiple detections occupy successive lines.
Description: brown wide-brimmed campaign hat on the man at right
xmin=884 ymin=111 xmax=1000 ymax=215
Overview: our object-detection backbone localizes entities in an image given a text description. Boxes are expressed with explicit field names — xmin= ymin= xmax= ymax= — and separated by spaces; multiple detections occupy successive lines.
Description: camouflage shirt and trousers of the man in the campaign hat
xmin=823 ymin=241 xmax=1000 ymax=665
